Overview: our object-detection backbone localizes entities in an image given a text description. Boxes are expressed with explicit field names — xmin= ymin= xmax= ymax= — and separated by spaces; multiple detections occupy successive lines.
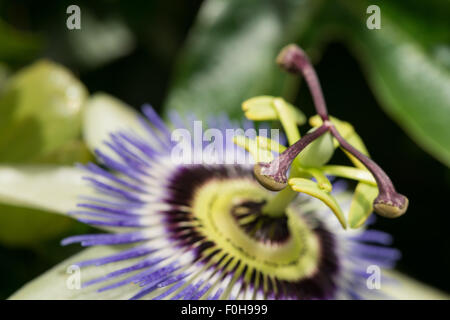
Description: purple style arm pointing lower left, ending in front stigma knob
xmin=253 ymin=121 xmax=331 ymax=191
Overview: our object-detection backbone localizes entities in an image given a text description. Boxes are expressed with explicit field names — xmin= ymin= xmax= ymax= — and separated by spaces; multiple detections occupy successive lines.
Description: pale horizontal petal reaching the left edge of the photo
xmin=0 ymin=165 xmax=90 ymax=214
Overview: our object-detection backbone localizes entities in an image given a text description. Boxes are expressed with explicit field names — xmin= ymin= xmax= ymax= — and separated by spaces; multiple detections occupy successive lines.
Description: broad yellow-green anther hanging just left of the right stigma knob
xmin=348 ymin=182 xmax=378 ymax=228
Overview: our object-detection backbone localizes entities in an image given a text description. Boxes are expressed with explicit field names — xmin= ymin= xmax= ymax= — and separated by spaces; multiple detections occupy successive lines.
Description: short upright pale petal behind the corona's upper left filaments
xmin=83 ymin=93 xmax=142 ymax=154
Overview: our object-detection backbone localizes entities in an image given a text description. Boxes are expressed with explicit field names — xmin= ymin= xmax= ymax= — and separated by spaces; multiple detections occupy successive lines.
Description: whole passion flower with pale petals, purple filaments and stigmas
xmin=0 ymin=45 xmax=444 ymax=299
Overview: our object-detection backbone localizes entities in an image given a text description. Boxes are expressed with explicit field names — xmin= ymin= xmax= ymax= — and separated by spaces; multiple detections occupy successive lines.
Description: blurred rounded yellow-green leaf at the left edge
xmin=0 ymin=61 xmax=87 ymax=162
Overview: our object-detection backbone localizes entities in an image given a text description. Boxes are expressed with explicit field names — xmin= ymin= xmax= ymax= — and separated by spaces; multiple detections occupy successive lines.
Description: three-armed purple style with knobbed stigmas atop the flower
xmin=254 ymin=44 xmax=409 ymax=218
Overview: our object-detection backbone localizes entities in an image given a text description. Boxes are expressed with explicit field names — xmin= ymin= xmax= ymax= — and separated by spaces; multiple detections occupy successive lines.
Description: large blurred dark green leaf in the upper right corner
xmin=347 ymin=3 xmax=450 ymax=166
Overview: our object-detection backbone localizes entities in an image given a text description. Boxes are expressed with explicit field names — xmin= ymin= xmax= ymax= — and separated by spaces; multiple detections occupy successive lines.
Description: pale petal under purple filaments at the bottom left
xmin=9 ymin=246 xmax=140 ymax=300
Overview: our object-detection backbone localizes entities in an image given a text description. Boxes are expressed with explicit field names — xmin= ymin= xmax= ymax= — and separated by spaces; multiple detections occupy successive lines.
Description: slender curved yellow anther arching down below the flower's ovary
xmin=289 ymin=178 xmax=346 ymax=229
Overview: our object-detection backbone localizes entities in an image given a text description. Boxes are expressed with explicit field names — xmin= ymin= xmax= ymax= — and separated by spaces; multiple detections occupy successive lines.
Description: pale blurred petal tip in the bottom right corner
xmin=381 ymin=270 xmax=450 ymax=300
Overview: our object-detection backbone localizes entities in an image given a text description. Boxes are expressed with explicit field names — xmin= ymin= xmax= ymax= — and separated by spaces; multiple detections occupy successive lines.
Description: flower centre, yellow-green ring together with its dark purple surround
xmin=163 ymin=166 xmax=320 ymax=281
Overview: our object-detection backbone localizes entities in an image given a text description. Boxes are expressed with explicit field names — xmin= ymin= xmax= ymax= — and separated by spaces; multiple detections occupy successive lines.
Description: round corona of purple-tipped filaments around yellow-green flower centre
xmin=51 ymin=103 xmax=399 ymax=299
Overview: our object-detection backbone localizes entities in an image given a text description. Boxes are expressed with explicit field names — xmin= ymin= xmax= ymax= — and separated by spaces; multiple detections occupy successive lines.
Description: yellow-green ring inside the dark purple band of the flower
xmin=192 ymin=179 xmax=320 ymax=281
